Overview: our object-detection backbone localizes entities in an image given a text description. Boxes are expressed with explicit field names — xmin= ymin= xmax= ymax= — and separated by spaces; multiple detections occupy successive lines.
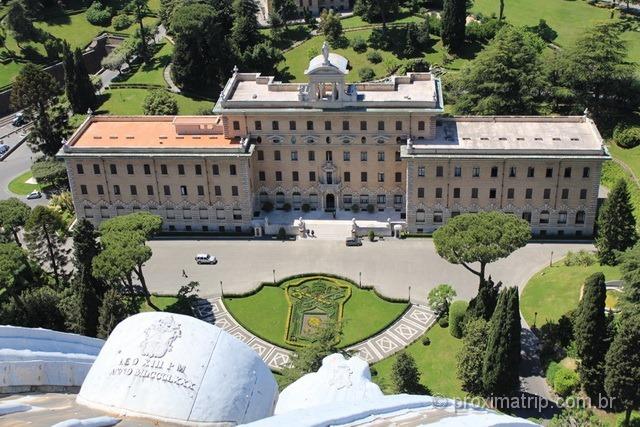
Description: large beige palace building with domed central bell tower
xmin=59 ymin=44 xmax=610 ymax=236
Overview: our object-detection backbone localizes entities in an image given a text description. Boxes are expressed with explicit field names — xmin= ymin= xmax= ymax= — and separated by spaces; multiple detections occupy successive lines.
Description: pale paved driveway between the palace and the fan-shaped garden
xmin=145 ymin=239 xmax=593 ymax=302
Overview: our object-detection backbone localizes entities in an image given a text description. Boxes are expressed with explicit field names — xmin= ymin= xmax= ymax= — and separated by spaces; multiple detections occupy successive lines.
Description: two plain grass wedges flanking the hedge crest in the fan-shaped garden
xmin=224 ymin=282 xmax=407 ymax=348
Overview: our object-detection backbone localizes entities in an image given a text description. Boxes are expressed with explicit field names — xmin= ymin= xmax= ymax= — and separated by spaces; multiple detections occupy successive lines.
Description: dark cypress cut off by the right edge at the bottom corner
xmin=604 ymin=310 xmax=640 ymax=426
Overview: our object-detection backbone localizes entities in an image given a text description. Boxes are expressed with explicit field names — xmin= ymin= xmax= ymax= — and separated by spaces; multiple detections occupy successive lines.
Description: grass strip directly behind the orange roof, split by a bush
xmin=97 ymin=89 xmax=214 ymax=115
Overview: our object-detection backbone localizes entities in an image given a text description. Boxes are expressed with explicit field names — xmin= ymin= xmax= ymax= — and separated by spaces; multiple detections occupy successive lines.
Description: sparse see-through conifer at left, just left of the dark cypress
xmin=24 ymin=206 xmax=69 ymax=285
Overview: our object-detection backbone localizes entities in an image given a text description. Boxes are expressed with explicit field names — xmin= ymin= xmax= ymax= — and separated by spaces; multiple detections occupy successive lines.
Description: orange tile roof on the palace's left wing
xmin=70 ymin=116 xmax=240 ymax=149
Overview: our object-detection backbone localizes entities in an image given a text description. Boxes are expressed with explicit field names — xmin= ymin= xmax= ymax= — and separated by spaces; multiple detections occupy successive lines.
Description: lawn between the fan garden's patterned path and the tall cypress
xmin=373 ymin=324 xmax=466 ymax=398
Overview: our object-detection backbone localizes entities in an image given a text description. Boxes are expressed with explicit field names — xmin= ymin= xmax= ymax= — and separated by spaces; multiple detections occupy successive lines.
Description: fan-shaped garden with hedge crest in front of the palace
xmin=223 ymin=274 xmax=408 ymax=349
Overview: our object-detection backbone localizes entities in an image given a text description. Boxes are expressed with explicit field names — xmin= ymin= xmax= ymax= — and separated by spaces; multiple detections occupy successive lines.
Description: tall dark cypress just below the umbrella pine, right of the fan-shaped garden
xmin=482 ymin=287 xmax=520 ymax=396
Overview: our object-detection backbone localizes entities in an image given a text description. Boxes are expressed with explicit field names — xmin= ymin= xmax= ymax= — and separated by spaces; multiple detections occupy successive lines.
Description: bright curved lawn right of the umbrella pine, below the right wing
xmin=520 ymin=261 xmax=620 ymax=327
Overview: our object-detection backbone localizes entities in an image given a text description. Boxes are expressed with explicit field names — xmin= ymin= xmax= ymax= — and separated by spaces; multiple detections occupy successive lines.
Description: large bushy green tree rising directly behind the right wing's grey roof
xmin=450 ymin=25 xmax=546 ymax=115
